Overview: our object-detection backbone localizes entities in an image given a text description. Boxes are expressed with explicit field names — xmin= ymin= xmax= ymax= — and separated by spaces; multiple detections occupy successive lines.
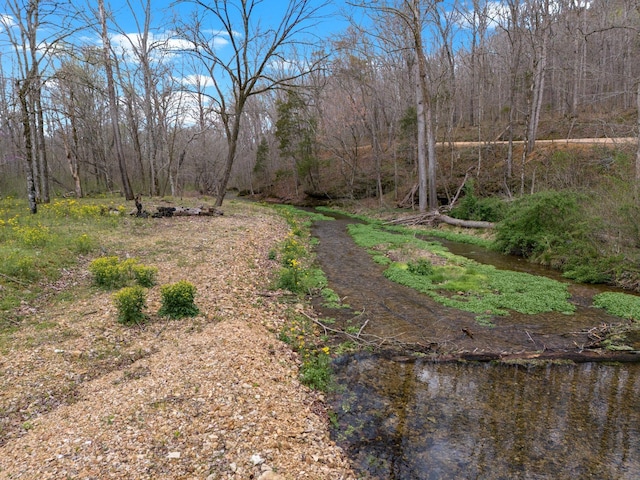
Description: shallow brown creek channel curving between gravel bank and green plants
xmin=312 ymin=216 xmax=640 ymax=362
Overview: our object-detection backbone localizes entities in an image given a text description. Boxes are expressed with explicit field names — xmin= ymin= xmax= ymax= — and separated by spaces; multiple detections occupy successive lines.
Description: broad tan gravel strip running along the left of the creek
xmin=0 ymin=204 xmax=355 ymax=480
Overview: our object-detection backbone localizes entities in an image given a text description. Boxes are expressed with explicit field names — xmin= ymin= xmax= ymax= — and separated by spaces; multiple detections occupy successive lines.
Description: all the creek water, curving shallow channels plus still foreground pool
xmin=313 ymin=219 xmax=640 ymax=480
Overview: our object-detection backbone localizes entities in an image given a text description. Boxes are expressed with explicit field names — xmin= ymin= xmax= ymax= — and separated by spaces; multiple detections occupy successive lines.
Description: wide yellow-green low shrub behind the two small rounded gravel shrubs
xmin=89 ymin=256 xmax=158 ymax=288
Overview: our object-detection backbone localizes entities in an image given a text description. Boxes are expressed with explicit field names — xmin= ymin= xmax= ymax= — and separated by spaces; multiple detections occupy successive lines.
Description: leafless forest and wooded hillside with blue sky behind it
xmin=0 ymin=0 xmax=640 ymax=283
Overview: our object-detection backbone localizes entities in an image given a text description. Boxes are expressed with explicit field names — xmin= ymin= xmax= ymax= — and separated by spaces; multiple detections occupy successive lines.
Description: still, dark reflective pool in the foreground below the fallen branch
xmin=333 ymin=354 xmax=640 ymax=480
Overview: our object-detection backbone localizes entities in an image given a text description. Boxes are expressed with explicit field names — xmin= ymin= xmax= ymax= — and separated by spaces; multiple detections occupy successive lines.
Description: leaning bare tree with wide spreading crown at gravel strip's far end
xmin=178 ymin=0 xmax=326 ymax=206
